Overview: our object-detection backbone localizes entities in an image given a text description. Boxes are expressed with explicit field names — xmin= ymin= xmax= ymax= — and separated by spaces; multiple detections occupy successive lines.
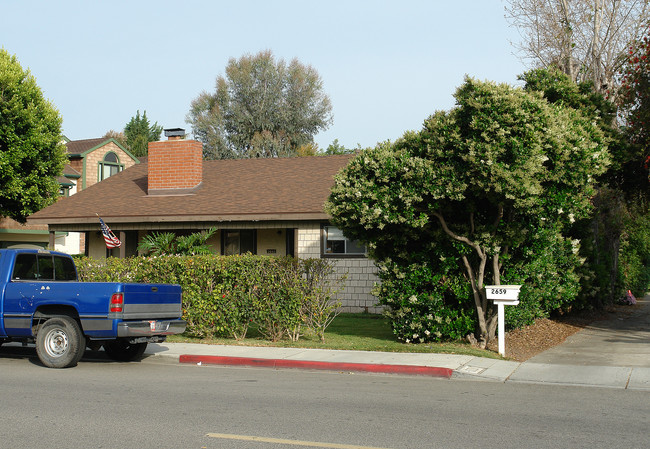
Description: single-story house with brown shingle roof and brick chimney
xmin=28 ymin=131 xmax=379 ymax=312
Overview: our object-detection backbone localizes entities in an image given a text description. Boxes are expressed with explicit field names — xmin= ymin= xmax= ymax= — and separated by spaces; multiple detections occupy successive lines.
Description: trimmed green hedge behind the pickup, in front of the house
xmin=77 ymin=255 xmax=343 ymax=341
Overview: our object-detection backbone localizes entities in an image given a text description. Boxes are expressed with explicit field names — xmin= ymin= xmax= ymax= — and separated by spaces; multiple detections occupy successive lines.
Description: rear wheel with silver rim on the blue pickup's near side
xmin=36 ymin=315 xmax=86 ymax=368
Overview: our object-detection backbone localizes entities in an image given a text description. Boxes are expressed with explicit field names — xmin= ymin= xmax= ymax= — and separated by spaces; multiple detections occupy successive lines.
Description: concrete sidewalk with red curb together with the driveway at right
xmin=146 ymin=299 xmax=650 ymax=391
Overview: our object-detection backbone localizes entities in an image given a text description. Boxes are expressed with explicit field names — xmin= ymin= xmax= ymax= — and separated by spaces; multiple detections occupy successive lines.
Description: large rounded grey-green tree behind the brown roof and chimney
xmin=186 ymin=51 xmax=332 ymax=159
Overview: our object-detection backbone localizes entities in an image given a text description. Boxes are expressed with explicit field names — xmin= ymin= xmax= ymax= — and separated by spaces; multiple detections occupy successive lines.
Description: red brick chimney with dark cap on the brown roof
xmin=148 ymin=128 xmax=203 ymax=195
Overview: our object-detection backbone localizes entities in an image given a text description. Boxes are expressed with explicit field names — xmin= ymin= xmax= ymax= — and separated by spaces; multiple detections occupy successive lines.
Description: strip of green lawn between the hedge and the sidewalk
xmin=167 ymin=313 xmax=500 ymax=358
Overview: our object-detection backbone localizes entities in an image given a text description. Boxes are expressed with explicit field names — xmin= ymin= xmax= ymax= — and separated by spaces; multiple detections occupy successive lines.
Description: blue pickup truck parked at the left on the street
xmin=0 ymin=249 xmax=186 ymax=368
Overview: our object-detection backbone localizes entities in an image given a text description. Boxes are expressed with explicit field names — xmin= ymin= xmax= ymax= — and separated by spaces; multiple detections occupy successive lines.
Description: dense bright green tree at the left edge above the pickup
xmin=0 ymin=49 xmax=67 ymax=223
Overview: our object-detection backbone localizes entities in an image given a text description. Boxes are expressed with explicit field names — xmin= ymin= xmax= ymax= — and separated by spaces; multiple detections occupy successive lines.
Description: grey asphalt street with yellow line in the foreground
xmin=0 ymin=350 xmax=650 ymax=449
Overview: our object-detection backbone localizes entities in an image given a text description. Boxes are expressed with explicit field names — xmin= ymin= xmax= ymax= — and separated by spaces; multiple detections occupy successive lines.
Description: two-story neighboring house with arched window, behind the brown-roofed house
xmin=0 ymin=138 xmax=139 ymax=254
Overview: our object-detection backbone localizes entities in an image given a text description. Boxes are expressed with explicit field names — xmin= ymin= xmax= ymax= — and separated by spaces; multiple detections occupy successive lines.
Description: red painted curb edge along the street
xmin=178 ymin=354 xmax=453 ymax=379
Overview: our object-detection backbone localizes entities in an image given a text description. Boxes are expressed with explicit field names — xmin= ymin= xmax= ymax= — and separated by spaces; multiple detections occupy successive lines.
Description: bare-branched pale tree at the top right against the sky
xmin=506 ymin=0 xmax=650 ymax=93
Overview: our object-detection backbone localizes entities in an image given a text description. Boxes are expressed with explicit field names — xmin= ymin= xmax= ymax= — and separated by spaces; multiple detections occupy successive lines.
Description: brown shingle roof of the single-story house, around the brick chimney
xmin=28 ymin=155 xmax=352 ymax=228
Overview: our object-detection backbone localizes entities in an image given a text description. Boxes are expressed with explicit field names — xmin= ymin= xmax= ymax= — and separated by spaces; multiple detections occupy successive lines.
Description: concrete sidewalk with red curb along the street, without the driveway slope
xmin=146 ymin=343 xmax=650 ymax=391
